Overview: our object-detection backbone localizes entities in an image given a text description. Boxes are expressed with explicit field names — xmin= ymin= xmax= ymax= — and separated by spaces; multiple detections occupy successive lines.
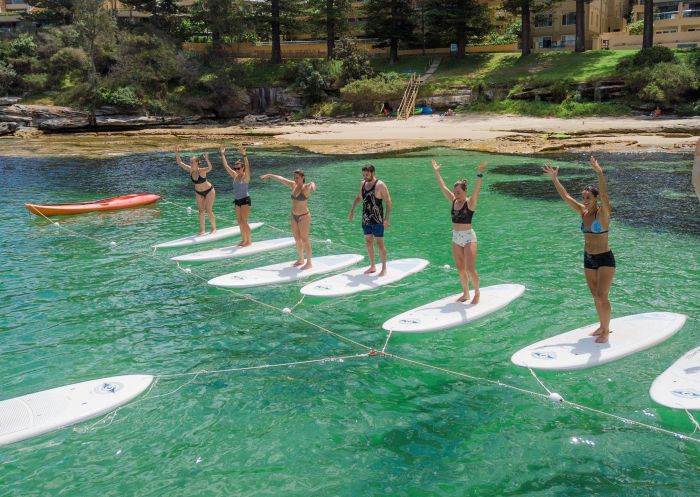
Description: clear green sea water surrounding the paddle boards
xmin=0 ymin=149 xmax=700 ymax=497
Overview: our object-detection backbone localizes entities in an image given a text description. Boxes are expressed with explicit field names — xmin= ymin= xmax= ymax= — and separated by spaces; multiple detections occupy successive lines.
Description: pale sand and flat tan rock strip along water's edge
xmin=0 ymin=114 xmax=700 ymax=156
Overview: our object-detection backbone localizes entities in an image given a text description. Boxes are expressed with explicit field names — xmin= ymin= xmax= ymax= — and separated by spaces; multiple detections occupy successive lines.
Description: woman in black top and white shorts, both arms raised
xmin=432 ymin=160 xmax=488 ymax=304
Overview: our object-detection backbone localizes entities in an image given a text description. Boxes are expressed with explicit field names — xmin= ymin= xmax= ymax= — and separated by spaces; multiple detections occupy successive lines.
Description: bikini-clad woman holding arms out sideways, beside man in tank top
xmin=260 ymin=169 xmax=316 ymax=269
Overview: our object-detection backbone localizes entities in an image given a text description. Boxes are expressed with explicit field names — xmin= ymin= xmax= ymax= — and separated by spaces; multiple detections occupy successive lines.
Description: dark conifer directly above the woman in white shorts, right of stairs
xmin=425 ymin=0 xmax=491 ymax=59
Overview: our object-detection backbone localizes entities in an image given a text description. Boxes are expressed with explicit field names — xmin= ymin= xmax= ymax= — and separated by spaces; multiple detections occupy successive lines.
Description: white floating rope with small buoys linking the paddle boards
xmin=31 ymin=203 xmax=700 ymax=443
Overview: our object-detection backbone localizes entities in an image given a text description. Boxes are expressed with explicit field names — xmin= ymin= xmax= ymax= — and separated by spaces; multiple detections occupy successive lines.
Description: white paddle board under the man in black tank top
xmin=301 ymin=259 xmax=428 ymax=297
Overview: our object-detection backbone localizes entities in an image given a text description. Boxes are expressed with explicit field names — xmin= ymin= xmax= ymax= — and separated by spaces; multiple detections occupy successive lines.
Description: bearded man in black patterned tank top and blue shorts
xmin=349 ymin=164 xmax=391 ymax=276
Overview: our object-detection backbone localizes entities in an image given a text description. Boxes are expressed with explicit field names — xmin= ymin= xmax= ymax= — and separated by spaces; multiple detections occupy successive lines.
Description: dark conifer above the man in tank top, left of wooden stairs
xmin=365 ymin=0 xmax=416 ymax=64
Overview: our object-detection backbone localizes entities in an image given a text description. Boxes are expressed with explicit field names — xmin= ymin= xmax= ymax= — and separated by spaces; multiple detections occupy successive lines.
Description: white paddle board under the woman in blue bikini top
xmin=511 ymin=312 xmax=686 ymax=371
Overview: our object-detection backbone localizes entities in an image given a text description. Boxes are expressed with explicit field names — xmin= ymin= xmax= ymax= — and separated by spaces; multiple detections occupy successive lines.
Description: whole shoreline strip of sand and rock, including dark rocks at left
xmin=0 ymin=98 xmax=700 ymax=156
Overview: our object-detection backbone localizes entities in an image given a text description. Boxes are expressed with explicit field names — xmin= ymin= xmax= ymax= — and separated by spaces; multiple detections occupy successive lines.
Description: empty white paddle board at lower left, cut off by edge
xmin=0 ymin=375 xmax=153 ymax=445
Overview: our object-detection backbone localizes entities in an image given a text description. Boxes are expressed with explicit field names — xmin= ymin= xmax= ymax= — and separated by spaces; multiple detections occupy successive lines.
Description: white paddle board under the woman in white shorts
xmin=382 ymin=283 xmax=525 ymax=333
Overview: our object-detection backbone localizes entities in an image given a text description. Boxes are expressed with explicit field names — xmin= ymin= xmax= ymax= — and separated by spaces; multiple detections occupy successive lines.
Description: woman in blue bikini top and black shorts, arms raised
xmin=543 ymin=156 xmax=615 ymax=343
